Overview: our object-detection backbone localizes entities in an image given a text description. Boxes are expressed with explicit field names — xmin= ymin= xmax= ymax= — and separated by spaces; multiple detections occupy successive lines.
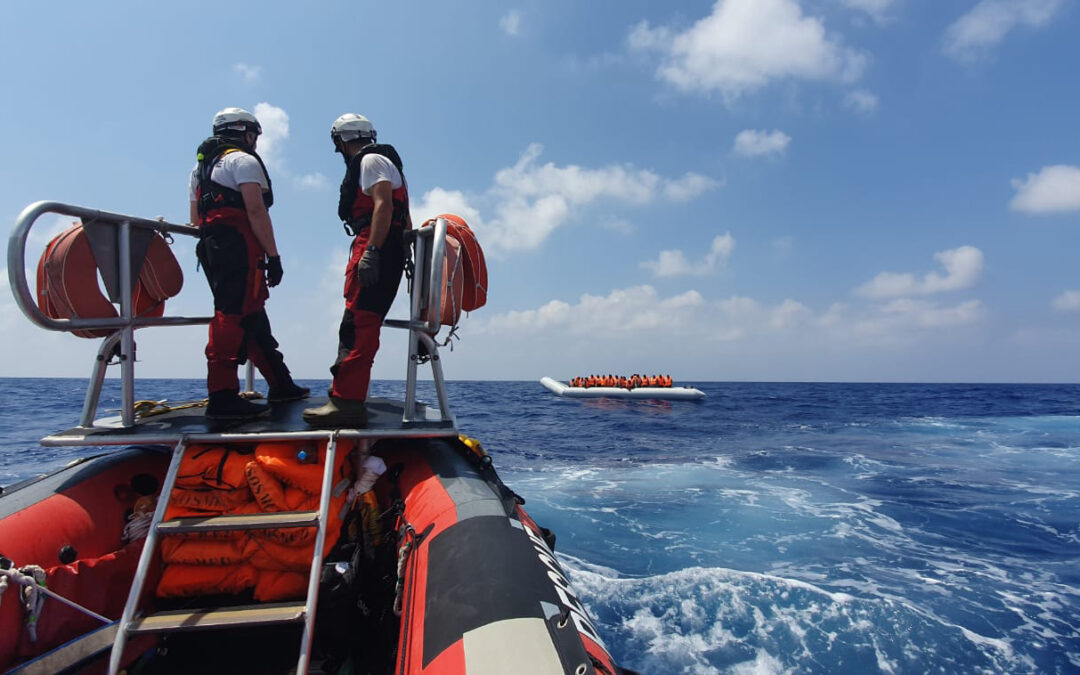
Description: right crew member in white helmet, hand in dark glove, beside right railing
xmin=303 ymin=112 xmax=413 ymax=428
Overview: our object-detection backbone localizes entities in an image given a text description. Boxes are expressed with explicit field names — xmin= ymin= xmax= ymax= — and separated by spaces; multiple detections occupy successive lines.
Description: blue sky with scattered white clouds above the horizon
xmin=0 ymin=0 xmax=1080 ymax=381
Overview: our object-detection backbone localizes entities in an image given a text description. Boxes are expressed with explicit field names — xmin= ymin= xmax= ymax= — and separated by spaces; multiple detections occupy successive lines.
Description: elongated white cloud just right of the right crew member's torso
xmin=413 ymin=144 xmax=719 ymax=253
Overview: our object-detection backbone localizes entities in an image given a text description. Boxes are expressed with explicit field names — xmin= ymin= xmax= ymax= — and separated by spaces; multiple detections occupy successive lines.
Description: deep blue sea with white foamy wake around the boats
xmin=0 ymin=379 xmax=1080 ymax=674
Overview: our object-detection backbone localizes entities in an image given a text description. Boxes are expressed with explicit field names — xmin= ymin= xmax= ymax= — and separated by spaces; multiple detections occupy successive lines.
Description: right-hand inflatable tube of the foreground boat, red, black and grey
xmin=388 ymin=441 xmax=621 ymax=675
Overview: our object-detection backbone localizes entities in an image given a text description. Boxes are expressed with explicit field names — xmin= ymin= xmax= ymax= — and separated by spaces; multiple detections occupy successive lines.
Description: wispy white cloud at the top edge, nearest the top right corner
xmin=945 ymin=0 xmax=1062 ymax=62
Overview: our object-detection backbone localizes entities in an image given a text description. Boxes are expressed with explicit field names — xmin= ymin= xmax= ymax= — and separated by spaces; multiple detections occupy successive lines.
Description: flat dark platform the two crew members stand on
xmin=41 ymin=396 xmax=458 ymax=447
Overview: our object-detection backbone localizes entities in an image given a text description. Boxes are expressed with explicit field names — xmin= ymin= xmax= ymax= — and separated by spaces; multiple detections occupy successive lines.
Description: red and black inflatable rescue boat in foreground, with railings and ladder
xmin=0 ymin=202 xmax=629 ymax=675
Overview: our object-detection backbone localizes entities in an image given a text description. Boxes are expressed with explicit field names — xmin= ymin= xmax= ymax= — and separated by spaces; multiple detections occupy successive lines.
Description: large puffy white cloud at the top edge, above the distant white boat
xmin=627 ymin=0 xmax=867 ymax=99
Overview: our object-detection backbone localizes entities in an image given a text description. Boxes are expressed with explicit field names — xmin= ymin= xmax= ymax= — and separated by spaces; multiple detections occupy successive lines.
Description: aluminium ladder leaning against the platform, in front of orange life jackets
xmin=109 ymin=431 xmax=347 ymax=675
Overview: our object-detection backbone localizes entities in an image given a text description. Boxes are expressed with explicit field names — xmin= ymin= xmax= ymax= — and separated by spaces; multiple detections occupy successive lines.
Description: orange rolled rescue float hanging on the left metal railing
xmin=38 ymin=222 xmax=184 ymax=338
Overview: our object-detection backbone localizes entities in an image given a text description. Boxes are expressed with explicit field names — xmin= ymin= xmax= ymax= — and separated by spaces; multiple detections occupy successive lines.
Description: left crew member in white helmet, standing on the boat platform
xmin=188 ymin=108 xmax=309 ymax=419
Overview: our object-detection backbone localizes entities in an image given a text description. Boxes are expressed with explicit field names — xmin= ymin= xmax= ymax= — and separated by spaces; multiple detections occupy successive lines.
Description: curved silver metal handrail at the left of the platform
xmin=8 ymin=201 xmax=211 ymax=428
